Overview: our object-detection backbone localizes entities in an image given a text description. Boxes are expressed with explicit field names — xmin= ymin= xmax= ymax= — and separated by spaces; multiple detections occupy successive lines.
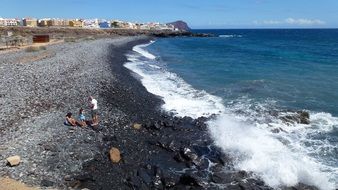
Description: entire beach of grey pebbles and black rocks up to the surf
xmin=0 ymin=36 xmax=316 ymax=189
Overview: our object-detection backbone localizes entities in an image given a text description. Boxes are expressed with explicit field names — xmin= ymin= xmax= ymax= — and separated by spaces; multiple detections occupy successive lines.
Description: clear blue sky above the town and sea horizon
xmin=0 ymin=0 xmax=338 ymax=29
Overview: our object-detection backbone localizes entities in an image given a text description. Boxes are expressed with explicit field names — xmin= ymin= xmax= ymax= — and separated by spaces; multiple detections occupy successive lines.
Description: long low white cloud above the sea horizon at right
xmin=253 ymin=18 xmax=326 ymax=26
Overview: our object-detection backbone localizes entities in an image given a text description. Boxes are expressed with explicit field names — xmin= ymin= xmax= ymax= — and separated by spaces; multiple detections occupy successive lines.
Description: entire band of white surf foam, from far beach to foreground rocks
xmin=125 ymin=41 xmax=338 ymax=190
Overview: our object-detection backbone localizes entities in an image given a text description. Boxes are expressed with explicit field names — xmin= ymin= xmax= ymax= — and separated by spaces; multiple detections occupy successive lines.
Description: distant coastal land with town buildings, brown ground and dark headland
xmin=0 ymin=17 xmax=191 ymax=50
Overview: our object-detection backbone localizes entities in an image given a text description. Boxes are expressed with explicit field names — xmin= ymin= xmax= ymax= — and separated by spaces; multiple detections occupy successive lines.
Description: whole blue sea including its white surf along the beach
xmin=125 ymin=29 xmax=338 ymax=190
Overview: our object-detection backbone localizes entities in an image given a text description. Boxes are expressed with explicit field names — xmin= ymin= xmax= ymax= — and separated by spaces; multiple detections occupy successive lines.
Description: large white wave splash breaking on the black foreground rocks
xmin=209 ymin=115 xmax=334 ymax=190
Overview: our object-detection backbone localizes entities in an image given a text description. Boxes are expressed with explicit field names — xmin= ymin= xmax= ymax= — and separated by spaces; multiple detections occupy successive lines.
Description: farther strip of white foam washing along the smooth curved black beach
xmin=125 ymin=44 xmax=224 ymax=118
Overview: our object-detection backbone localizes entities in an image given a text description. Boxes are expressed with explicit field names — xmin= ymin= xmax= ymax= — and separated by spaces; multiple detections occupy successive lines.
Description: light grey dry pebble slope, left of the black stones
xmin=0 ymin=37 xmax=148 ymax=186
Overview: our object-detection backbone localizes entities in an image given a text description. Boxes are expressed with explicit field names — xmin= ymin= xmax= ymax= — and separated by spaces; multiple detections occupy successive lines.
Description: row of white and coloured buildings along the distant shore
xmin=0 ymin=17 xmax=179 ymax=31
